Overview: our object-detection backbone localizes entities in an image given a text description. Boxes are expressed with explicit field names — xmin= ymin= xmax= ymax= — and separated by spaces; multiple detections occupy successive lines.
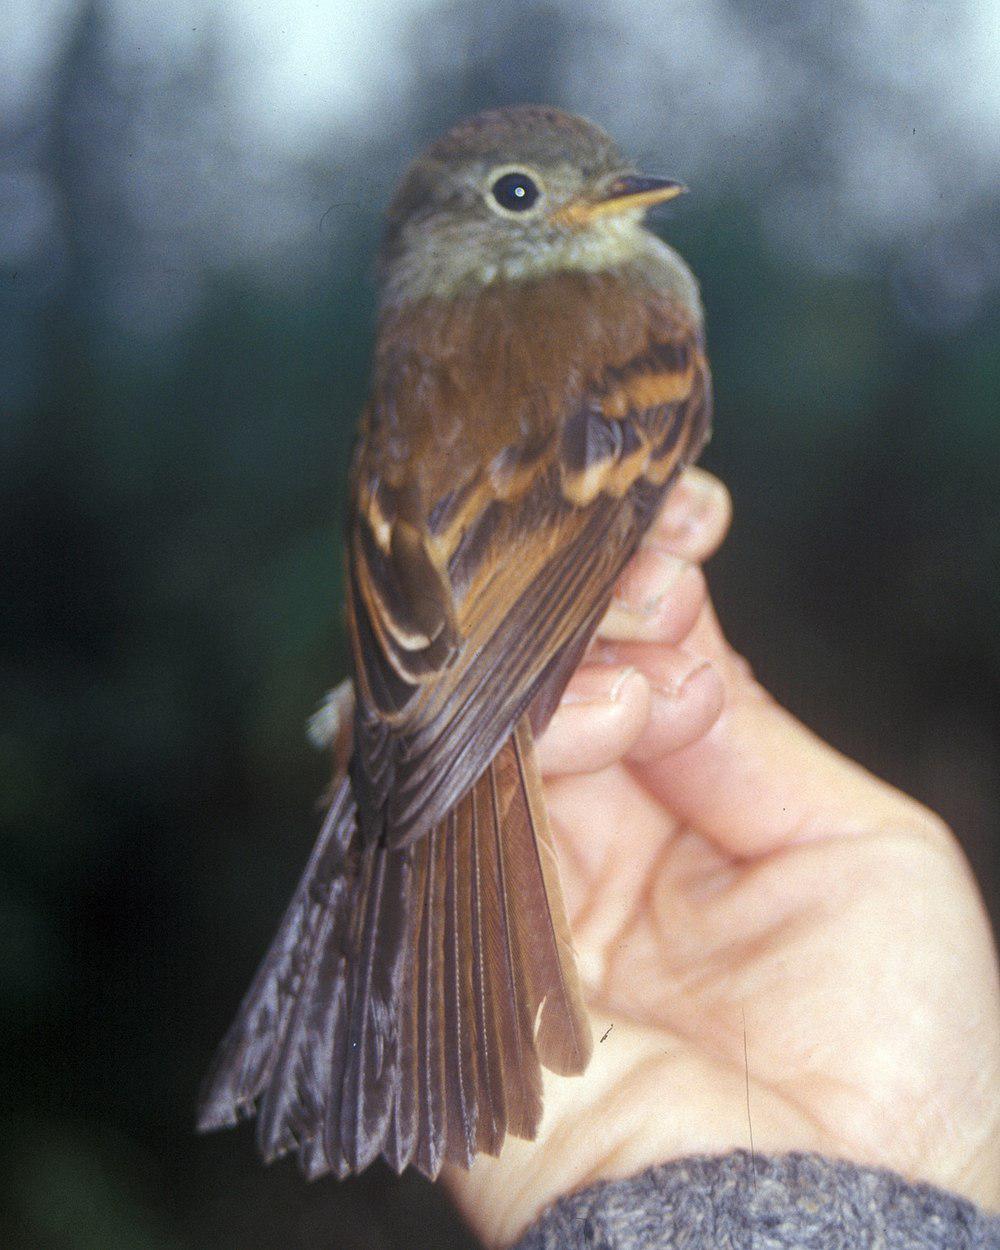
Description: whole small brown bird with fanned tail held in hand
xmin=199 ymin=106 xmax=710 ymax=1178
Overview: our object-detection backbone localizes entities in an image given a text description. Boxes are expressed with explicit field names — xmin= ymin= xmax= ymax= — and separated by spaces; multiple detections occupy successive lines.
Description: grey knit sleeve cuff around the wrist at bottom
xmin=515 ymin=1150 xmax=1000 ymax=1250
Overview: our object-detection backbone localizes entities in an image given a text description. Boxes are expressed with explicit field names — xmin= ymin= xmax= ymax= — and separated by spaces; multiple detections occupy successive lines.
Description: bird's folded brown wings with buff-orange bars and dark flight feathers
xmin=349 ymin=296 xmax=710 ymax=844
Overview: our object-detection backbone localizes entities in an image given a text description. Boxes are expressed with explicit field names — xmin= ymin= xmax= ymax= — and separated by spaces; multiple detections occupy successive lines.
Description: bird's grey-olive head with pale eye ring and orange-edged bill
xmin=381 ymin=105 xmax=684 ymax=304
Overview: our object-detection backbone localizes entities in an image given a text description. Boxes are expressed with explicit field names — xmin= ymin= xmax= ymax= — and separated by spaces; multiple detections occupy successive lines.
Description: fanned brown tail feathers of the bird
xmin=199 ymin=719 xmax=591 ymax=1178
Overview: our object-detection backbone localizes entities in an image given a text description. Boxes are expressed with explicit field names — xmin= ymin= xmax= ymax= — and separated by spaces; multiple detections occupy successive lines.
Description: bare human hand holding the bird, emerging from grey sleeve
xmin=446 ymin=470 xmax=1000 ymax=1244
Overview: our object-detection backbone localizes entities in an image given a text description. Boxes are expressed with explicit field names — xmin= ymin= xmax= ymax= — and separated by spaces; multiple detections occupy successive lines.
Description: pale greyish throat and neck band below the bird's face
xmin=383 ymin=213 xmax=701 ymax=320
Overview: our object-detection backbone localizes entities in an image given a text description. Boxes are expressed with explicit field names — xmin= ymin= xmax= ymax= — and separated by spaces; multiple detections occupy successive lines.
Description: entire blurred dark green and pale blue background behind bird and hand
xmin=0 ymin=0 xmax=1000 ymax=1250
